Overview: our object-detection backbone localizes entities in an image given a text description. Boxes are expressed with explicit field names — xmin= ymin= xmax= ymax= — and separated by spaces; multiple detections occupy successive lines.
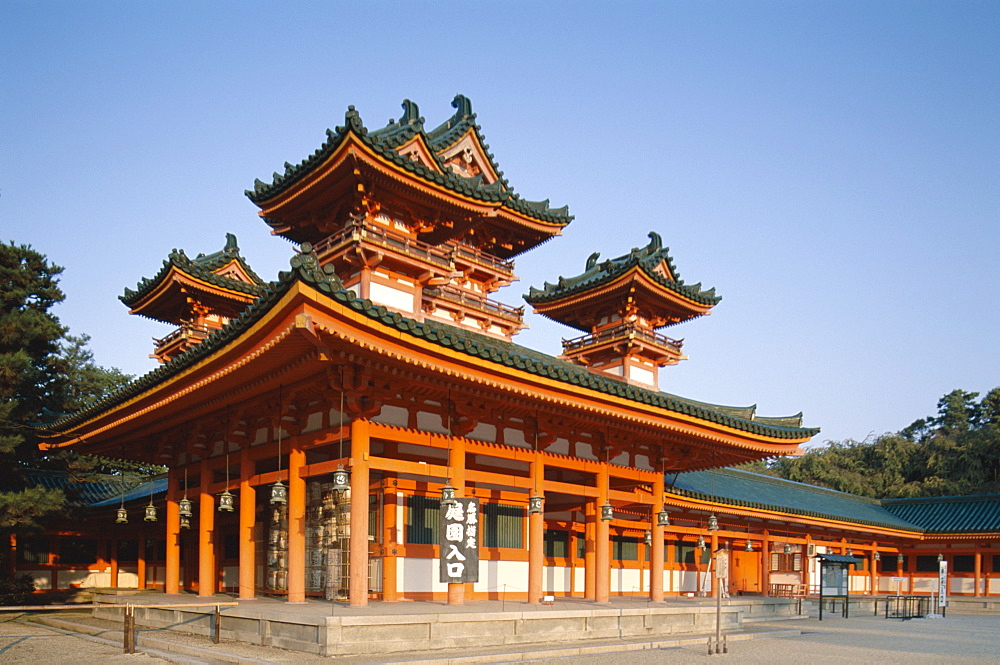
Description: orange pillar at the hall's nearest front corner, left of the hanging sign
xmin=347 ymin=418 xmax=371 ymax=607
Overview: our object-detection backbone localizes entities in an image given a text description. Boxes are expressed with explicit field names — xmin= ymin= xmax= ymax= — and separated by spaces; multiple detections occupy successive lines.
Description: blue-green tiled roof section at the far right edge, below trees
xmin=882 ymin=494 xmax=1000 ymax=533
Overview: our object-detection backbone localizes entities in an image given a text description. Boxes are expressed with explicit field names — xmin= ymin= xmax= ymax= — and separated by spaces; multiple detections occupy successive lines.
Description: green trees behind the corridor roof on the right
xmin=742 ymin=387 xmax=1000 ymax=498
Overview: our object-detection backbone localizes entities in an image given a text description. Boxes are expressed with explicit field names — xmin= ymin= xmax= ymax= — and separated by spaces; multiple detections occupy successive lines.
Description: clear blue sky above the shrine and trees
xmin=0 ymin=0 xmax=1000 ymax=442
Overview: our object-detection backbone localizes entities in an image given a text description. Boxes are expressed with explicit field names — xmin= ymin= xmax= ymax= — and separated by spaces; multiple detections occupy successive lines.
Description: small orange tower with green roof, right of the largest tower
xmin=524 ymin=232 xmax=721 ymax=389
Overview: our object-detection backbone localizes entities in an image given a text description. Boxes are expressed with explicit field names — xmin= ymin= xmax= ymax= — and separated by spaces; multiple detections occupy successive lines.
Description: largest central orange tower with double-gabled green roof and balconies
xmin=246 ymin=95 xmax=572 ymax=340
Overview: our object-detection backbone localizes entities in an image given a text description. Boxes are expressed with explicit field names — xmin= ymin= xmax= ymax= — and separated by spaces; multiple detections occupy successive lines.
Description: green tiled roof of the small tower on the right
xmin=524 ymin=232 xmax=722 ymax=320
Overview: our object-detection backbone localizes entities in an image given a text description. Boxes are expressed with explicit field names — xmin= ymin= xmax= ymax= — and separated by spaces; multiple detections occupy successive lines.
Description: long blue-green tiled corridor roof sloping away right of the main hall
xmin=665 ymin=469 xmax=920 ymax=531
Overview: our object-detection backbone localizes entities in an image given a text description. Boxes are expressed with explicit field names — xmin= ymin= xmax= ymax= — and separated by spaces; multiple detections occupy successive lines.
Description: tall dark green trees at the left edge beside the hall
xmin=0 ymin=242 xmax=145 ymax=537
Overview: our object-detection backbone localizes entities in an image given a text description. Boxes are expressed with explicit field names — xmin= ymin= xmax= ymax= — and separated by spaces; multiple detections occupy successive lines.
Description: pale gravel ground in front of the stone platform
xmin=0 ymin=614 xmax=1000 ymax=665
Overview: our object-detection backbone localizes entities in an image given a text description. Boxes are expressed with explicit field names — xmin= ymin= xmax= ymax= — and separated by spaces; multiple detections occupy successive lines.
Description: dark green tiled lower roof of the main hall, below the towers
xmin=48 ymin=243 xmax=819 ymax=439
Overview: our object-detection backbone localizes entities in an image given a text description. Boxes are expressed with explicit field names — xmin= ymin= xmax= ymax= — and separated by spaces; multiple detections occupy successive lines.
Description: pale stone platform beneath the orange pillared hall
xmin=94 ymin=596 xmax=797 ymax=656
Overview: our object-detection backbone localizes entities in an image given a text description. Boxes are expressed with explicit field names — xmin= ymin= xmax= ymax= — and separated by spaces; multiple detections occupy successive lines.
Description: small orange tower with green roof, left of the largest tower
xmin=119 ymin=233 xmax=264 ymax=363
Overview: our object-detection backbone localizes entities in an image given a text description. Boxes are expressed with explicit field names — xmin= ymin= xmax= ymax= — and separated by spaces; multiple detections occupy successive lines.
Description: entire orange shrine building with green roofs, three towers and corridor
xmin=27 ymin=95 xmax=1000 ymax=605
